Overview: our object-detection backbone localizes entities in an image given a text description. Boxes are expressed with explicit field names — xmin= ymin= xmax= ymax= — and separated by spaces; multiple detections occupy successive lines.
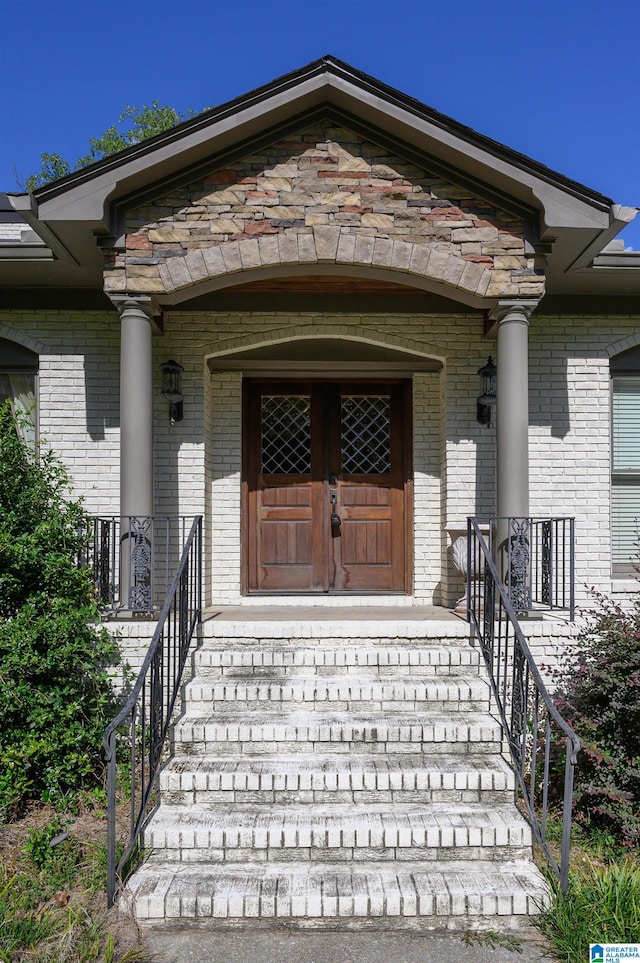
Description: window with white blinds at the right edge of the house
xmin=611 ymin=348 xmax=640 ymax=574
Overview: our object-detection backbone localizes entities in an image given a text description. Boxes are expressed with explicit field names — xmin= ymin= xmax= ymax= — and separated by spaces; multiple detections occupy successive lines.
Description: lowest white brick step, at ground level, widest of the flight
xmin=126 ymin=857 xmax=549 ymax=932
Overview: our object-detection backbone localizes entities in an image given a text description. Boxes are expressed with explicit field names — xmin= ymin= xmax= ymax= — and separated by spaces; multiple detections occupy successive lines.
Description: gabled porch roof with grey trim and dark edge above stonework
xmin=0 ymin=56 xmax=636 ymax=302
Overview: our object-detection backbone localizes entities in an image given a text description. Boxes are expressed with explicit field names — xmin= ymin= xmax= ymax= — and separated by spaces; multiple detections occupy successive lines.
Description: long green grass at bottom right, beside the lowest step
xmin=536 ymin=826 xmax=640 ymax=963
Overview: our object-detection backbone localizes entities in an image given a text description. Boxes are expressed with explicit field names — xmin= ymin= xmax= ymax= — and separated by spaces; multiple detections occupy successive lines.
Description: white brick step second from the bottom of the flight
xmin=144 ymin=804 xmax=532 ymax=862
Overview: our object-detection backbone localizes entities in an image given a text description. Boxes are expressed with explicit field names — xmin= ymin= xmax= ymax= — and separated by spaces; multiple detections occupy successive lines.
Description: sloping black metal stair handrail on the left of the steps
xmin=103 ymin=516 xmax=202 ymax=906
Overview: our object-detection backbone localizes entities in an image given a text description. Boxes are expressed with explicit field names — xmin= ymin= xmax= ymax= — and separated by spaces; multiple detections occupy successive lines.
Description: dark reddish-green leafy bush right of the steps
xmin=555 ymin=592 xmax=640 ymax=847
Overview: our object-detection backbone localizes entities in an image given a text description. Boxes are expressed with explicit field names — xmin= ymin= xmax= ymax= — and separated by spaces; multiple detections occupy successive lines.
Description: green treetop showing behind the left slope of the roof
xmin=26 ymin=100 xmax=196 ymax=191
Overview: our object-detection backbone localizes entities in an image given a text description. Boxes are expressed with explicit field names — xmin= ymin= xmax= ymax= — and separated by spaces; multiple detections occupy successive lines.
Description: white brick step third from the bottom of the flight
xmin=160 ymin=754 xmax=515 ymax=806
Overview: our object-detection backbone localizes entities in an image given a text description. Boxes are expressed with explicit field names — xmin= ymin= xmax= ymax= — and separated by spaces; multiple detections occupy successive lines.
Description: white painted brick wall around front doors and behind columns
xmin=5 ymin=311 xmax=640 ymax=604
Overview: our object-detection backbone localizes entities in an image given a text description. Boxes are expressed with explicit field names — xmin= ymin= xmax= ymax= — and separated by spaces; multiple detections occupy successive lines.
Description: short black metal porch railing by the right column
xmin=491 ymin=517 xmax=575 ymax=621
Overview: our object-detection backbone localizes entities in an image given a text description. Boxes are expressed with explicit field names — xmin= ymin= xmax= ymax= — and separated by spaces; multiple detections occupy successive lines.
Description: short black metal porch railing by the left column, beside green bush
xmin=81 ymin=515 xmax=192 ymax=614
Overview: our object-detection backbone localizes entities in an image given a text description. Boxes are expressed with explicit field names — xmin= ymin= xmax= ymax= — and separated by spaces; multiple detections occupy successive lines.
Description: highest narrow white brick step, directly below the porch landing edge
xmin=194 ymin=640 xmax=481 ymax=678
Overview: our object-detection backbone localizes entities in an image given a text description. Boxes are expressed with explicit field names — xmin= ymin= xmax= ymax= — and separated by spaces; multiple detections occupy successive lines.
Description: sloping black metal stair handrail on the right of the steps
xmin=467 ymin=518 xmax=580 ymax=892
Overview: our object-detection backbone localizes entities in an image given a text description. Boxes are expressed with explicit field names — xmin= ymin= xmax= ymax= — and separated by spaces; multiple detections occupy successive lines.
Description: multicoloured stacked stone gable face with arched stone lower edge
xmin=104 ymin=119 xmax=544 ymax=307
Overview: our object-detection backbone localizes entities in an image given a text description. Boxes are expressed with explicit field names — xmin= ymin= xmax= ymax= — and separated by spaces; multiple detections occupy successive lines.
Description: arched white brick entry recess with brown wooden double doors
xmin=207 ymin=332 xmax=443 ymax=602
